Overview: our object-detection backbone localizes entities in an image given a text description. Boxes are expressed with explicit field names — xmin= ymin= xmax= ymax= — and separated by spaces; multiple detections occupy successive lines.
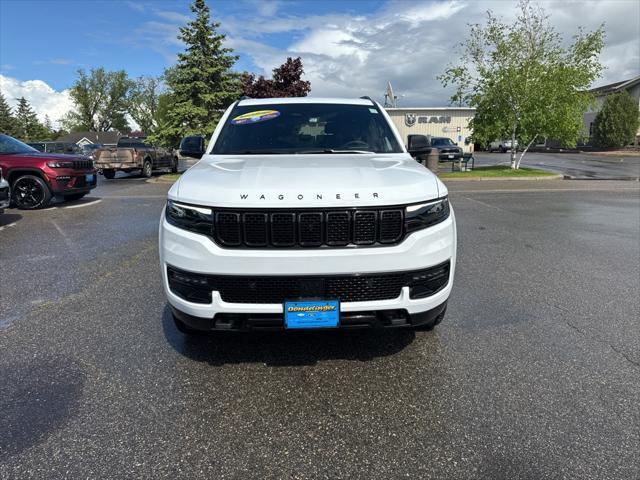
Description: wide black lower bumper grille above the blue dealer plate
xmin=167 ymin=262 xmax=450 ymax=304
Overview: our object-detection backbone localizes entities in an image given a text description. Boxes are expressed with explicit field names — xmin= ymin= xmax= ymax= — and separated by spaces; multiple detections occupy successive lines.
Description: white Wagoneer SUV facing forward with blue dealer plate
xmin=159 ymin=98 xmax=456 ymax=334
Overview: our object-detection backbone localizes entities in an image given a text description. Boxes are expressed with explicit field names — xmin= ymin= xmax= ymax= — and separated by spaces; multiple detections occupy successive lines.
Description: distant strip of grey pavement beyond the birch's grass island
xmin=474 ymin=152 xmax=640 ymax=180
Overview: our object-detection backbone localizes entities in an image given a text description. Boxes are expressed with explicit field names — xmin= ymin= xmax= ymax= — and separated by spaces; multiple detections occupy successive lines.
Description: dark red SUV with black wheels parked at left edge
xmin=0 ymin=134 xmax=97 ymax=210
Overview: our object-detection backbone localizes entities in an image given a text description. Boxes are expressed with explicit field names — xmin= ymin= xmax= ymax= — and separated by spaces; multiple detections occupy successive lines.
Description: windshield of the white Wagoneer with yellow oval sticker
xmin=212 ymin=103 xmax=402 ymax=155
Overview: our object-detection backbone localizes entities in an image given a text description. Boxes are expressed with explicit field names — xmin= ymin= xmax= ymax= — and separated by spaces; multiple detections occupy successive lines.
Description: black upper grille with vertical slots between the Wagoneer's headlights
xmin=214 ymin=209 xmax=404 ymax=248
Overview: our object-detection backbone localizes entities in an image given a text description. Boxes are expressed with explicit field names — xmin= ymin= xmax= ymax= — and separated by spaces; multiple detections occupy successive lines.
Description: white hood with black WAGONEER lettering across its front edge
xmin=169 ymin=153 xmax=439 ymax=208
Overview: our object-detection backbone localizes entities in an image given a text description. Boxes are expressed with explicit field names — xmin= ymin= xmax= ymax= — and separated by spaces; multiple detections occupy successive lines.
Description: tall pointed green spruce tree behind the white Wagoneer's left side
xmin=155 ymin=0 xmax=241 ymax=145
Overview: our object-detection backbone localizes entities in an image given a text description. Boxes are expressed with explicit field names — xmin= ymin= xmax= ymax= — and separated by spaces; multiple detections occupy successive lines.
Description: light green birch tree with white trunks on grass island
xmin=439 ymin=0 xmax=604 ymax=168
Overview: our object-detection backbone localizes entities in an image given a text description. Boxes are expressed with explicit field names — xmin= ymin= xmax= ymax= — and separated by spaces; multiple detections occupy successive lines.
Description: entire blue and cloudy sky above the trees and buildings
xmin=0 ymin=0 xmax=640 ymax=124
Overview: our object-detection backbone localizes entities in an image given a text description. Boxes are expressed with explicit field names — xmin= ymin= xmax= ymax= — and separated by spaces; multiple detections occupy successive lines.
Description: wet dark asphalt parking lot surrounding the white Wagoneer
xmin=0 ymin=177 xmax=640 ymax=479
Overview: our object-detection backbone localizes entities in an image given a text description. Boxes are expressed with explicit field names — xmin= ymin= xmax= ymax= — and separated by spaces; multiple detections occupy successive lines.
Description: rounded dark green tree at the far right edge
xmin=593 ymin=92 xmax=640 ymax=148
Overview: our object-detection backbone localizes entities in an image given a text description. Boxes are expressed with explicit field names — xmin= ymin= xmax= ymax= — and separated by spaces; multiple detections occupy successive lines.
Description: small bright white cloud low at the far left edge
xmin=0 ymin=74 xmax=73 ymax=127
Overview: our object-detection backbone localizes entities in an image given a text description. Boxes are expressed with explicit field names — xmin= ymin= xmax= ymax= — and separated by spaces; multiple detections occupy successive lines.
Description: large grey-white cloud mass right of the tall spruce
xmin=221 ymin=0 xmax=640 ymax=106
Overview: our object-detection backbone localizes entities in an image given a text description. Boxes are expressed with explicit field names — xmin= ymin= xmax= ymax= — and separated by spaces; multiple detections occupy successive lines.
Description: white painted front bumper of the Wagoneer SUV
xmin=159 ymin=209 xmax=456 ymax=330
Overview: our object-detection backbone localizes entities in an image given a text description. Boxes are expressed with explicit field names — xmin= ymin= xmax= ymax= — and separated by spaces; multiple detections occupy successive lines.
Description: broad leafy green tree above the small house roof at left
xmin=63 ymin=67 xmax=133 ymax=132
